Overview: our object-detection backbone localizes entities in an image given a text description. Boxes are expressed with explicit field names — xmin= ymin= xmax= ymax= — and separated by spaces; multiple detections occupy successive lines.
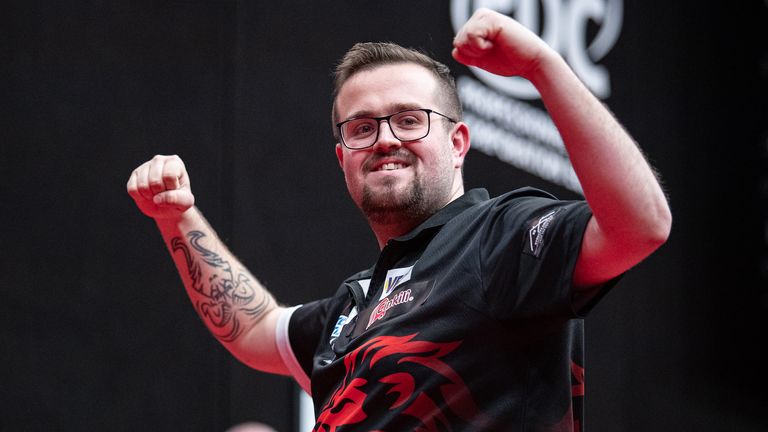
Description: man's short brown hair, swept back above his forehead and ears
xmin=331 ymin=42 xmax=462 ymax=136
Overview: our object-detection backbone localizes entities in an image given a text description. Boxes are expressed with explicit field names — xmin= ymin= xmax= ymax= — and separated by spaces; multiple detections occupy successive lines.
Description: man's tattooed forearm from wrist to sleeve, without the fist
xmin=156 ymin=207 xmax=281 ymax=372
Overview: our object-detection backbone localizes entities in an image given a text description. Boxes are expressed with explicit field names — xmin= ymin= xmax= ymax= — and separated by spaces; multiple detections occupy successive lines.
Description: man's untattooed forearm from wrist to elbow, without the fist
xmin=531 ymin=53 xmax=671 ymax=241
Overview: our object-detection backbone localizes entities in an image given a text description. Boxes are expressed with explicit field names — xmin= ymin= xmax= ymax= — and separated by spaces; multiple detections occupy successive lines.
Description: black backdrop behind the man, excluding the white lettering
xmin=0 ymin=0 xmax=768 ymax=432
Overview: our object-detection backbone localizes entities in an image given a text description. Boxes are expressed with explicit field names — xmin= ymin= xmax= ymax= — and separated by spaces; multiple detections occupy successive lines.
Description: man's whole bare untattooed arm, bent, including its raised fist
xmin=453 ymin=9 xmax=672 ymax=287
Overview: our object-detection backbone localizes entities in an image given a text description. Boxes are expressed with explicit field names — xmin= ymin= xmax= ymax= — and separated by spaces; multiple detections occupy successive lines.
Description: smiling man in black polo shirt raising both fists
xmin=128 ymin=9 xmax=671 ymax=431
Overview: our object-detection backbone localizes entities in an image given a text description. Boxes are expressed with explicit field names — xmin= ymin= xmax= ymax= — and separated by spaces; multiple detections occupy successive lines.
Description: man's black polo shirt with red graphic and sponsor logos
xmin=280 ymin=188 xmax=607 ymax=432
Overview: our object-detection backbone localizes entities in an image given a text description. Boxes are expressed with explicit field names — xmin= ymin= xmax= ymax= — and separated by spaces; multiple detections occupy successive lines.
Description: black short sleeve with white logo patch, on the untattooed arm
xmin=480 ymin=197 xmax=592 ymax=319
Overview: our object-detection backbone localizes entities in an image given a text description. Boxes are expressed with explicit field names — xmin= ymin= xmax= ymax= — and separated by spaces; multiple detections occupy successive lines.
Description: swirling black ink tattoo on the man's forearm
xmin=171 ymin=231 xmax=272 ymax=342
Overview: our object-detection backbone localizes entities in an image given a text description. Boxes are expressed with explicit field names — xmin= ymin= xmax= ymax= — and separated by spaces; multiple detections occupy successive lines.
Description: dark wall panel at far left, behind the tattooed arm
xmin=0 ymin=2 xmax=236 ymax=430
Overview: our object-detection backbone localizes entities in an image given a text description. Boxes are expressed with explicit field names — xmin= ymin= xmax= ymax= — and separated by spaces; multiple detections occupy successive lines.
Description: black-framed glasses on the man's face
xmin=336 ymin=108 xmax=456 ymax=150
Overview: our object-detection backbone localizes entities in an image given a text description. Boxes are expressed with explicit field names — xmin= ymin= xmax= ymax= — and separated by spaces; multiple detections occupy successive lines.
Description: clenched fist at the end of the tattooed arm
xmin=127 ymin=155 xmax=195 ymax=219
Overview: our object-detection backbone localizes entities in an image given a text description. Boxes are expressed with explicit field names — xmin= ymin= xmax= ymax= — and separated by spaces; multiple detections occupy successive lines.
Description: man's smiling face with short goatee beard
xmin=336 ymin=63 xmax=469 ymax=224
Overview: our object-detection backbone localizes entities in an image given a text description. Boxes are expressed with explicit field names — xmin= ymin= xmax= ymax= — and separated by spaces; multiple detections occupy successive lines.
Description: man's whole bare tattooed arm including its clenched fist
xmin=127 ymin=156 xmax=288 ymax=375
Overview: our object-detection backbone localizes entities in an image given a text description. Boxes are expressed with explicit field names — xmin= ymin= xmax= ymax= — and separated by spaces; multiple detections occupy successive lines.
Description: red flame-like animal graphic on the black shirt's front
xmin=313 ymin=334 xmax=488 ymax=432
